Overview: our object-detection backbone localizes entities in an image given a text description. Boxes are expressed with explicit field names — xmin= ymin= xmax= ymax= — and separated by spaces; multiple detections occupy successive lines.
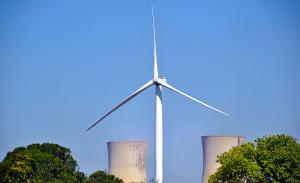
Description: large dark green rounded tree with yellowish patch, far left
xmin=0 ymin=143 xmax=85 ymax=183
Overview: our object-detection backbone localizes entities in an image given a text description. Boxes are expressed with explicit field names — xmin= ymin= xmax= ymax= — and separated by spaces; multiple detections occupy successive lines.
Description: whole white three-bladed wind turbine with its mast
xmin=87 ymin=2 xmax=229 ymax=183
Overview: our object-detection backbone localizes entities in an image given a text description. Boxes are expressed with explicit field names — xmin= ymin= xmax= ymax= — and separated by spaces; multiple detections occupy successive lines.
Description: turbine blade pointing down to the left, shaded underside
xmin=86 ymin=80 xmax=153 ymax=131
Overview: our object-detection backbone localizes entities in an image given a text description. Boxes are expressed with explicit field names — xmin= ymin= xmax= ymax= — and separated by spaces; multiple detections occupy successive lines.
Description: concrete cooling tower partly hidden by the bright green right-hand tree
xmin=201 ymin=136 xmax=246 ymax=183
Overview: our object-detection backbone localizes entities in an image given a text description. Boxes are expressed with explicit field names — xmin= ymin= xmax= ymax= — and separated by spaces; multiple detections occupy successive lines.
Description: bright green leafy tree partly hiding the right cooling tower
xmin=208 ymin=135 xmax=300 ymax=183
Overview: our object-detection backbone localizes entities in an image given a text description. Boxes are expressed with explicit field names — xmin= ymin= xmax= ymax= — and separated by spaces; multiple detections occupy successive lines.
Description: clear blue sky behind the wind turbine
xmin=0 ymin=0 xmax=300 ymax=183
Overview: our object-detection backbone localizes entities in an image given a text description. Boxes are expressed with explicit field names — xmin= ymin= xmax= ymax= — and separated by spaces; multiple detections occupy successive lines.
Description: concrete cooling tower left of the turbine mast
xmin=107 ymin=141 xmax=148 ymax=183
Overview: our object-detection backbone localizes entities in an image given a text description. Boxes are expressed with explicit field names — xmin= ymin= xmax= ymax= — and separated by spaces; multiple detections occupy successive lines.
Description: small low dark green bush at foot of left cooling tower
xmin=87 ymin=171 xmax=124 ymax=183
